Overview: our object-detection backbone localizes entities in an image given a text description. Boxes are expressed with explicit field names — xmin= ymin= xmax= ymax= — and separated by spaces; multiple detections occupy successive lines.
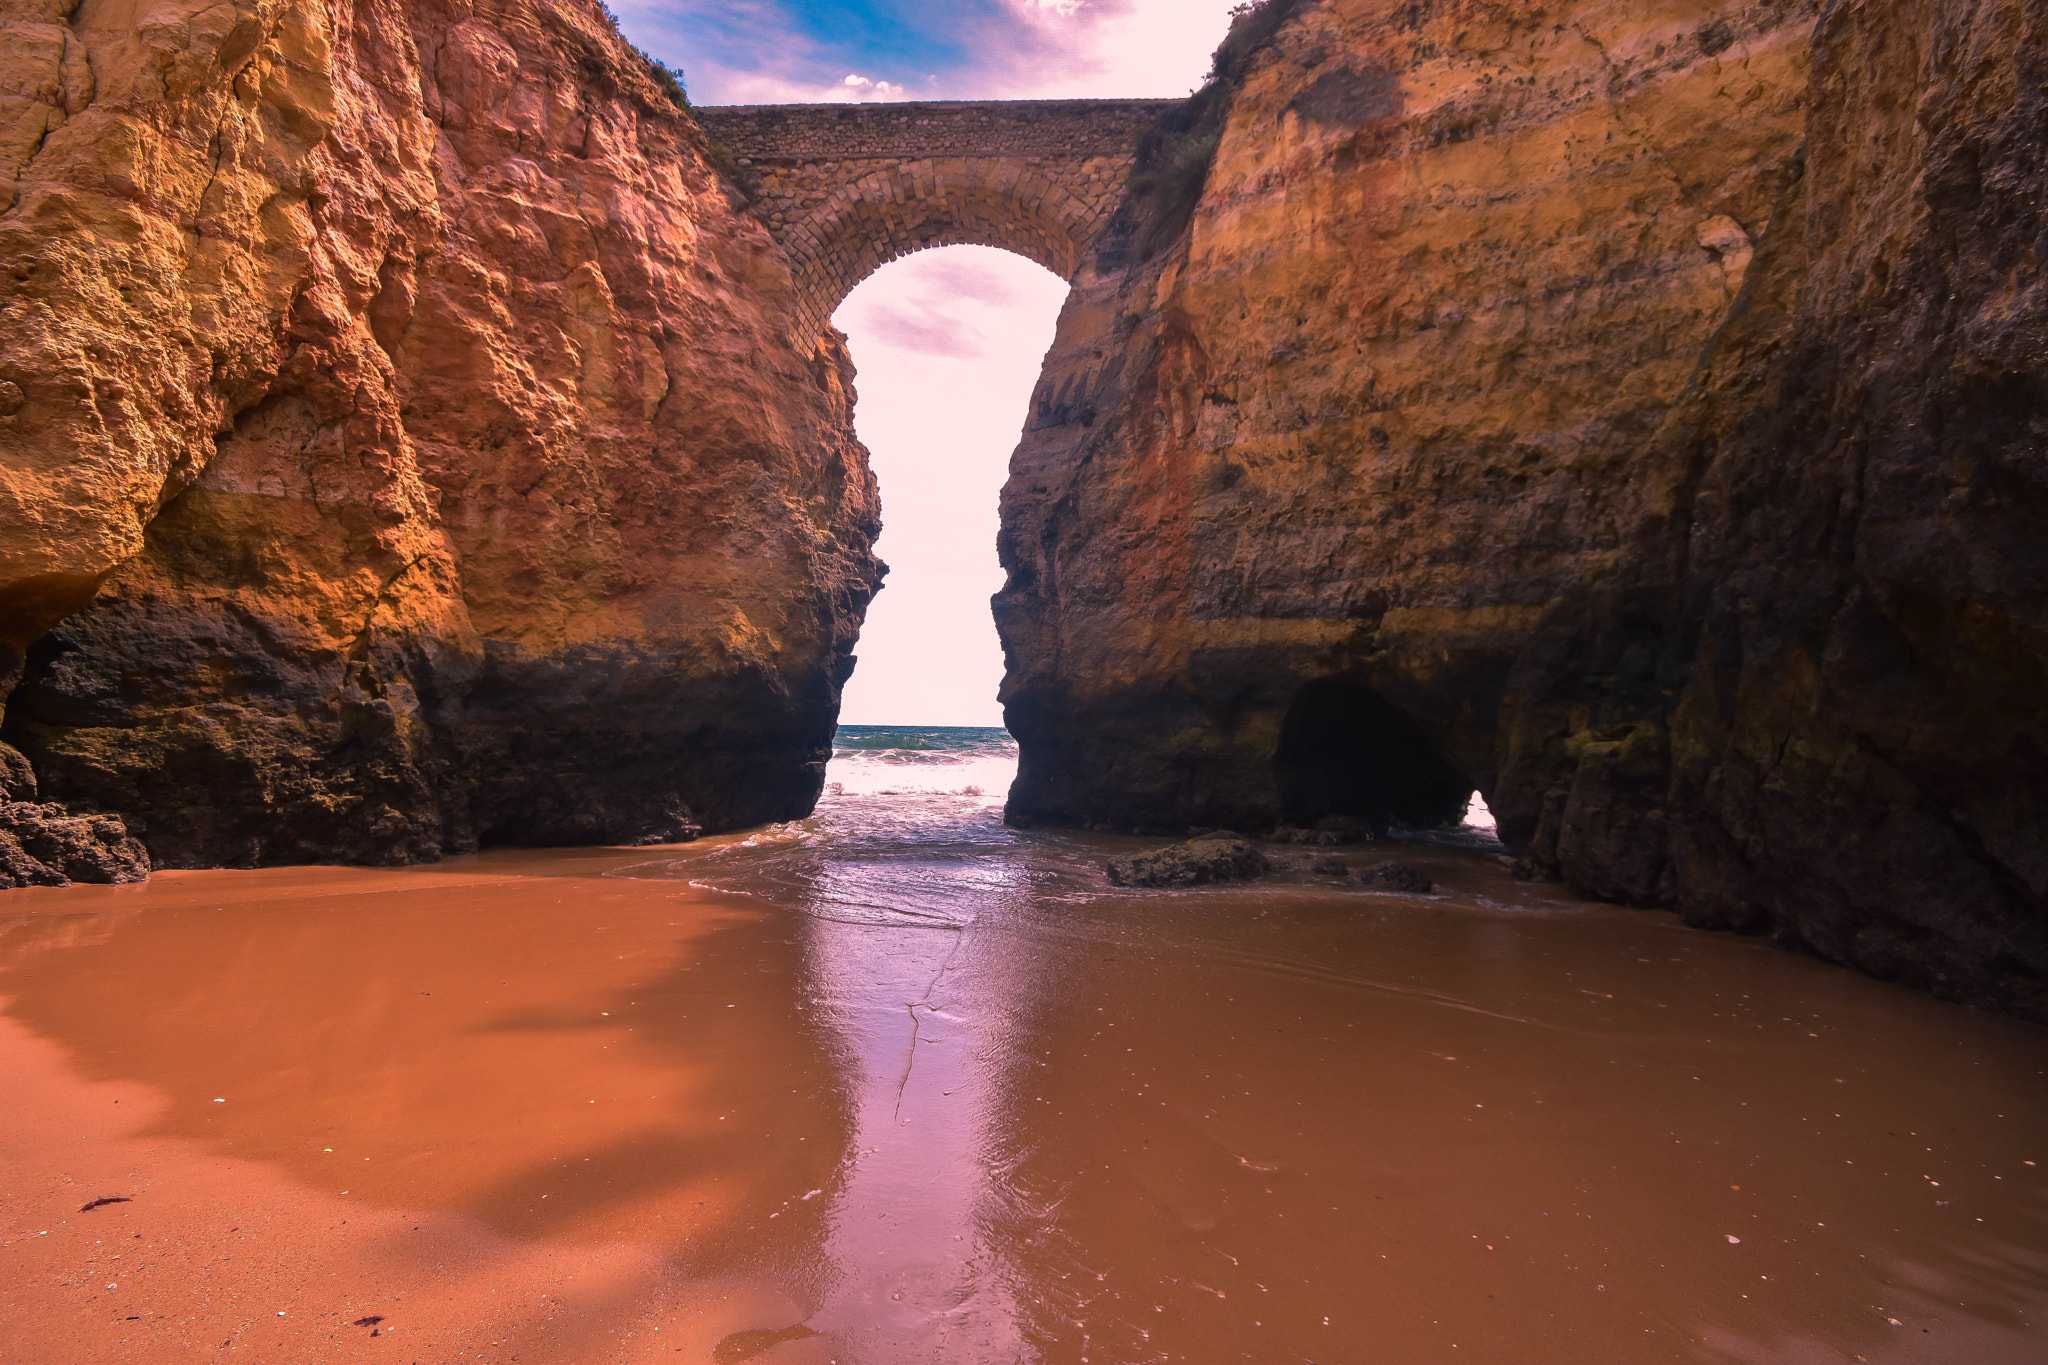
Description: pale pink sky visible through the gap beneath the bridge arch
xmin=831 ymin=246 xmax=1067 ymax=729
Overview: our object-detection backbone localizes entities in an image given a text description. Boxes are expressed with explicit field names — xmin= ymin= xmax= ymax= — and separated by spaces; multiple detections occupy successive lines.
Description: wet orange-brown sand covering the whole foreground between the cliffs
xmin=0 ymin=817 xmax=2048 ymax=1365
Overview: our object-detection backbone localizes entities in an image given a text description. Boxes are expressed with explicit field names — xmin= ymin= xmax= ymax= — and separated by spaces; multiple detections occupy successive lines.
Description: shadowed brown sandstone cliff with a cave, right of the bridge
xmin=997 ymin=0 xmax=2048 ymax=1017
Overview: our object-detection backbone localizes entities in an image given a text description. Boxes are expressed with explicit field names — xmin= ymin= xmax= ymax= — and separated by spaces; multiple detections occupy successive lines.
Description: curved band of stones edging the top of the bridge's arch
xmin=793 ymin=186 xmax=1094 ymax=327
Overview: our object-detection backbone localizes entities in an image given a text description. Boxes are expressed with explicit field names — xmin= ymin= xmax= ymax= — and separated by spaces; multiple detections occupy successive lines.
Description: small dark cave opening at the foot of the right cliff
xmin=1274 ymin=677 xmax=1475 ymax=831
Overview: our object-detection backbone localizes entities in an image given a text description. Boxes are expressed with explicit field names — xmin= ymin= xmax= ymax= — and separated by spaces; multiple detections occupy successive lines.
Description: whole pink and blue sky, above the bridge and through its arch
xmin=612 ymin=0 xmax=1233 ymax=726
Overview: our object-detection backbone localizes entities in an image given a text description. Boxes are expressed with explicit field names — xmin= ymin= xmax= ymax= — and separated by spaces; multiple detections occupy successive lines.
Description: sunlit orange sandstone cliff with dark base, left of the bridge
xmin=0 ymin=0 xmax=881 ymax=884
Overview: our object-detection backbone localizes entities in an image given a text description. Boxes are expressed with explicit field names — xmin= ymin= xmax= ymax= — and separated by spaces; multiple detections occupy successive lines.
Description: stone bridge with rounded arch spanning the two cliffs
xmin=694 ymin=100 xmax=1178 ymax=329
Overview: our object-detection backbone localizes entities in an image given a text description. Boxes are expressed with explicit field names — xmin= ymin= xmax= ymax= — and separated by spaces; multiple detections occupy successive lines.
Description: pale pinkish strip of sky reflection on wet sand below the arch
xmin=663 ymin=782 xmax=1059 ymax=1361
